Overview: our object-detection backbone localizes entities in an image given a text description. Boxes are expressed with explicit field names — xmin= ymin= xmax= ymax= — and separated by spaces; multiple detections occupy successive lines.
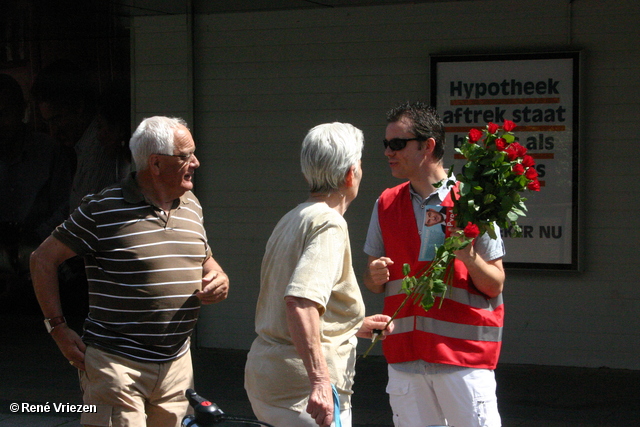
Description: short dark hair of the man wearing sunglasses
xmin=387 ymin=101 xmax=445 ymax=160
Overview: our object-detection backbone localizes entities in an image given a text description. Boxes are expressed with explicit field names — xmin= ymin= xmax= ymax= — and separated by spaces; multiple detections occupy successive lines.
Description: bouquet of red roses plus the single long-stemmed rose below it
xmin=365 ymin=120 xmax=540 ymax=355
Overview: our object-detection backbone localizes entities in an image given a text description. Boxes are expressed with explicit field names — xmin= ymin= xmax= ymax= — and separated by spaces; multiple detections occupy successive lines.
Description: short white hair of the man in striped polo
xmin=129 ymin=116 xmax=187 ymax=171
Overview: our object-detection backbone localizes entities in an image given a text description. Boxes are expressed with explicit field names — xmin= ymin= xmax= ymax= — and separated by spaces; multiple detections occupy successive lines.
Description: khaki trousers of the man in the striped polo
xmin=79 ymin=346 xmax=193 ymax=427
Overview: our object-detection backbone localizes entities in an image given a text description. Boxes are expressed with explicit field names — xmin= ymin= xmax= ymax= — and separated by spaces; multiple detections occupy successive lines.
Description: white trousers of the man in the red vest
xmin=387 ymin=365 xmax=502 ymax=427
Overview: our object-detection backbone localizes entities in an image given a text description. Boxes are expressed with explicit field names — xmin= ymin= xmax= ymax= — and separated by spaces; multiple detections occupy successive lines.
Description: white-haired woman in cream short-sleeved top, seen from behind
xmin=245 ymin=123 xmax=392 ymax=427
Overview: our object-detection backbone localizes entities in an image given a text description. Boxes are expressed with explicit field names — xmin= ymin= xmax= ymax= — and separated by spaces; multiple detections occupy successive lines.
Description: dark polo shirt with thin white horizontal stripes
xmin=53 ymin=173 xmax=211 ymax=362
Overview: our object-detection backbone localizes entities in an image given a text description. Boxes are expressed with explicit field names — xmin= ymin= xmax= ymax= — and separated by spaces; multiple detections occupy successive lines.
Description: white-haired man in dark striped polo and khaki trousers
xmin=31 ymin=117 xmax=229 ymax=427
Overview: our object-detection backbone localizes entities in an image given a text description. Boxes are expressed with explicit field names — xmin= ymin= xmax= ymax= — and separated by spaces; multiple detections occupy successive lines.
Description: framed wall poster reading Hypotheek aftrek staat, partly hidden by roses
xmin=431 ymin=52 xmax=579 ymax=270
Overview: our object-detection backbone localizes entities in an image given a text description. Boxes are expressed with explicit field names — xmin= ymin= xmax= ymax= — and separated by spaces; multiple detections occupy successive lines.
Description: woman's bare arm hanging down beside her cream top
xmin=285 ymin=296 xmax=334 ymax=426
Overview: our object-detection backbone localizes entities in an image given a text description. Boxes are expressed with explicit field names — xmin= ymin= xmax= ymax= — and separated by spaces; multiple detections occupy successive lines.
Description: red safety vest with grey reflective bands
xmin=378 ymin=182 xmax=504 ymax=369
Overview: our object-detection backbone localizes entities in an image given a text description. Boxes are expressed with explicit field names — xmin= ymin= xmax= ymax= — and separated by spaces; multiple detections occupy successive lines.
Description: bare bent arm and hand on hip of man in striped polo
xmin=30 ymin=236 xmax=86 ymax=370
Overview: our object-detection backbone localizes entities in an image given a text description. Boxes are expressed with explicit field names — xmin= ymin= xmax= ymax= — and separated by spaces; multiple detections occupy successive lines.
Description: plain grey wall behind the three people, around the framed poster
xmin=132 ymin=0 xmax=640 ymax=369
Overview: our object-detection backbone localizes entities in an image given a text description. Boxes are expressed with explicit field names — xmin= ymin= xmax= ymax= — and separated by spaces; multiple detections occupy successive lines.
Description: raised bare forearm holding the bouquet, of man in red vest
xmin=456 ymin=245 xmax=505 ymax=298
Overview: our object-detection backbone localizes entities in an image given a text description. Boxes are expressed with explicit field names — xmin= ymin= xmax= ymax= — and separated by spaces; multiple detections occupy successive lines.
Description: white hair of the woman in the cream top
xmin=300 ymin=122 xmax=364 ymax=193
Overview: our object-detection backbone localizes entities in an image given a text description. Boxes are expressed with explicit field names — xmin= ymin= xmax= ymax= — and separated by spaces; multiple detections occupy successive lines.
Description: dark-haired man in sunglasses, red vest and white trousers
xmin=364 ymin=102 xmax=505 ymax=427
